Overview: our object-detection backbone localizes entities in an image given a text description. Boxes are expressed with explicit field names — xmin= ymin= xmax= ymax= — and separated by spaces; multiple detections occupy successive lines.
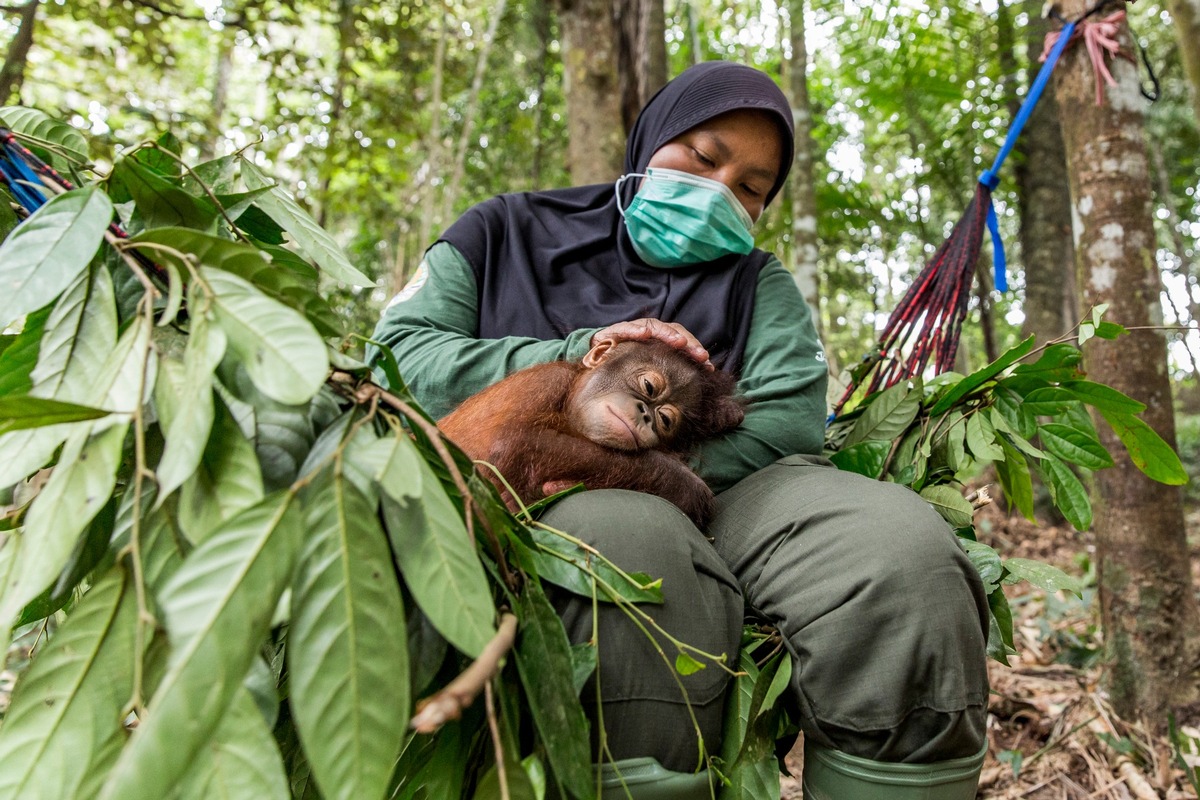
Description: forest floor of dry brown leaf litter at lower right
xmin=782 ymin=494 xmax=1200 ymax=800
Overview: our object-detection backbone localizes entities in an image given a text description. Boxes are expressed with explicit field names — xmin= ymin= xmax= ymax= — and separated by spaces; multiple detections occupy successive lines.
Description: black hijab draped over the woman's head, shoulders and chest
xmin=439 ymin=61 xmax=793 ymax=373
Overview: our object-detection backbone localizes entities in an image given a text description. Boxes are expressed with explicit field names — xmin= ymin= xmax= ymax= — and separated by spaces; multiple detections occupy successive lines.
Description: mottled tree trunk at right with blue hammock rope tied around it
xmin=1055 ymin=0 xmax=1200 ymax=726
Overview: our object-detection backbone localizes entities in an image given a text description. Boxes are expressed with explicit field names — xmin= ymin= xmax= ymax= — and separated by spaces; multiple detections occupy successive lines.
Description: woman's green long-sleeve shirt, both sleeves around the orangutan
xmin=374 ymin=242 xmax=827 ymax=492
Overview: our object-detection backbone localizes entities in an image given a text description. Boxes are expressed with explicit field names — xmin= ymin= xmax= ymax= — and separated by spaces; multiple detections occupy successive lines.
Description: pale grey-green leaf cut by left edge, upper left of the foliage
xmin=0 ymin=186 xmax=113 ymax=330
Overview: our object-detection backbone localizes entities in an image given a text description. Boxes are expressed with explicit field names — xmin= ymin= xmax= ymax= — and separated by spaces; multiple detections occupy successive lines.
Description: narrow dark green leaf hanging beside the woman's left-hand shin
xmin=515 ymin=582 xmax=595 ymax=800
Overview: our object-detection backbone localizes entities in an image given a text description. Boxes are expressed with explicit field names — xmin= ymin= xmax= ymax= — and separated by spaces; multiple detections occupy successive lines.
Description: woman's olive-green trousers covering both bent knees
xmin=544 ymin=456 xmax=988 ymax=771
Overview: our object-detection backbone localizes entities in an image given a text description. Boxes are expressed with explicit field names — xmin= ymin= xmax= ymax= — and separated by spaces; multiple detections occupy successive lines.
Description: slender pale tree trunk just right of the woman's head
xmin=787 ymin=0 xmax=821 ymax=335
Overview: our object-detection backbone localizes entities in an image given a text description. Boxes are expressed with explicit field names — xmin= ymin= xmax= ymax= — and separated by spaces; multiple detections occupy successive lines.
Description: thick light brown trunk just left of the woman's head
xmin=557 ymin=0 xmax=625 ymax=186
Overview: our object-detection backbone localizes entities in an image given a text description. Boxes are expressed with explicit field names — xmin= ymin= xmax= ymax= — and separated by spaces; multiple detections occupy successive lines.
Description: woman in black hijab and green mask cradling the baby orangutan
xmin=376 ymin=62 xmax=988 ymax=800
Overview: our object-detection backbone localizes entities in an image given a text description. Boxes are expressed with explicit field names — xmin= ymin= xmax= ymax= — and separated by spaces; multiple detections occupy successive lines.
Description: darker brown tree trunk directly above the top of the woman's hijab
xmin=612 ymin=0 xmax=667 ymax=132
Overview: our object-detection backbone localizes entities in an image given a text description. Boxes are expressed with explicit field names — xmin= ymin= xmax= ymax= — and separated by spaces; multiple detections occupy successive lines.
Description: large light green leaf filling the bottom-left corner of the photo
xmin=0 ymin=567 xmax=140 ymax=800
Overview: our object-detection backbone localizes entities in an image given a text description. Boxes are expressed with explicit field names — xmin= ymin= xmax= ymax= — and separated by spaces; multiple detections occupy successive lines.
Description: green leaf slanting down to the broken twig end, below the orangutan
xmin=383 ymin=463 xmax=496 ymax=657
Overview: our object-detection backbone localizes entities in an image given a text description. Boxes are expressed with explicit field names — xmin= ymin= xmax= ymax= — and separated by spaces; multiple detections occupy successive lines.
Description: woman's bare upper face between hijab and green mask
xmin=648 ymin=108 xmax=784 ymax=222
